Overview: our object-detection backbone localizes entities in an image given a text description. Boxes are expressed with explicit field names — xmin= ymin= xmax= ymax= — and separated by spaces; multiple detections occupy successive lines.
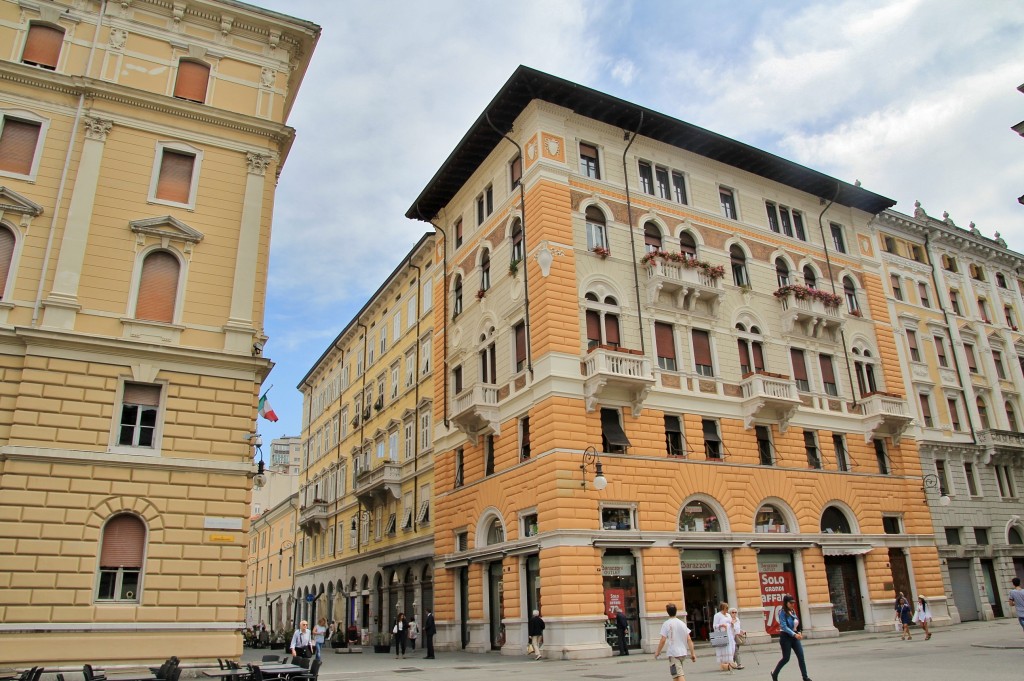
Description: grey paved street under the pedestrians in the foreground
xmin=243 ymin=619 xmax=1024 ymax=681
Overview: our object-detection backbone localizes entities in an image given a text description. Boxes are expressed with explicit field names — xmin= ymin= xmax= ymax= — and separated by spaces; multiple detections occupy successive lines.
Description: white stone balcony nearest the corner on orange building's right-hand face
xmin=581 ymin=345 xmax=654 ymax=417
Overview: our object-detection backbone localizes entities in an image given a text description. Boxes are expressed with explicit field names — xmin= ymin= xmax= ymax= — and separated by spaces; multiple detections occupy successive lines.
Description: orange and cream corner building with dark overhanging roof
xmin=407 ymin=68 xmax=948 ymax=657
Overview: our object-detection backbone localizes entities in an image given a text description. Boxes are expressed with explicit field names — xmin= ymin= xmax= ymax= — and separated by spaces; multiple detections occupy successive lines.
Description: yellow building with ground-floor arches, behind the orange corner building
xmin=295 ymin=233 xmax=441 ymax=635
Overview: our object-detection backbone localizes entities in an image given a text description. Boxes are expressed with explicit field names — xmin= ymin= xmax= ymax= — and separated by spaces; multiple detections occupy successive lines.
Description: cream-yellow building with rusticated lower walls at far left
xmin=0 ymin=0 xmax=319 ymax=667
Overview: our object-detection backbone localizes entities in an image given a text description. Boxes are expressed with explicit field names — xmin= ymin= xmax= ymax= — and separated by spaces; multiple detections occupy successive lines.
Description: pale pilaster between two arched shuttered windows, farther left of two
xmin=43 ymin=116 xmax=114 ymax=330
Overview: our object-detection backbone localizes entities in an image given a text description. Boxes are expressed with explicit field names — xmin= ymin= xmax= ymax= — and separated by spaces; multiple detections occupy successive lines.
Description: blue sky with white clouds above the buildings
xmin=250 ymin=0 xmax=1024 ymax=438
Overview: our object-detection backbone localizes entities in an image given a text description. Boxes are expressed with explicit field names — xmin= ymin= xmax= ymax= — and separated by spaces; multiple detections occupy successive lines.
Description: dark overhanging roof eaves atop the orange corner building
xmin=406 ymin=66 xmax=896 ymax=220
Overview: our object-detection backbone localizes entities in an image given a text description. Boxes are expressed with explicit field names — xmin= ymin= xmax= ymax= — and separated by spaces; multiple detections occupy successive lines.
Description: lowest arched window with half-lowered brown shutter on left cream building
xmin=96 ymin=513 xmax=145 ymax=603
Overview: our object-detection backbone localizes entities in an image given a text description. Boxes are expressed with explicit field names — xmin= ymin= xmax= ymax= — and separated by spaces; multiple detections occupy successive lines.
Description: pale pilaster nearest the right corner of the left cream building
xmin=224 ymin=152 xmax=270 ymax=352
